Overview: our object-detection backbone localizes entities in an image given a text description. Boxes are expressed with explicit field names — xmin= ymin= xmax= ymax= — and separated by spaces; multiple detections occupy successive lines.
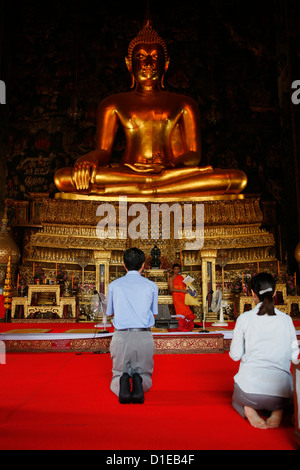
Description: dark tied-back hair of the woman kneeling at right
xmin=251 ymin=273 xmax=276 ymax=315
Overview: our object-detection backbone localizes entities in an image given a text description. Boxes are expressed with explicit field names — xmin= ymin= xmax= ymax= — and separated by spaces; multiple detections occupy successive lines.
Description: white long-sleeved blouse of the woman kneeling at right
xmin=229 ymin=304 xmax=299 ymax=397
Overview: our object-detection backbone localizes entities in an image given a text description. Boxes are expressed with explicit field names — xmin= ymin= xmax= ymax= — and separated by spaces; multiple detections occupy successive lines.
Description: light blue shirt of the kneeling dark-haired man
xmin=107 ymin=271 xmax=158 ymax=330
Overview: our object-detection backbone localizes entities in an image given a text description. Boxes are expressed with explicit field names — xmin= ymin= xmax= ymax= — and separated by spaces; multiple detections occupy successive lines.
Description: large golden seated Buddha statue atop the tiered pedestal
xmin=54 ymin=20 xmax=247 ymax=197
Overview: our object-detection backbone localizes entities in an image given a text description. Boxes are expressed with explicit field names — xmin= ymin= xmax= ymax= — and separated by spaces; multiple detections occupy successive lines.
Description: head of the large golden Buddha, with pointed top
xmin=125 ymin=20 xmax=169 ymax=88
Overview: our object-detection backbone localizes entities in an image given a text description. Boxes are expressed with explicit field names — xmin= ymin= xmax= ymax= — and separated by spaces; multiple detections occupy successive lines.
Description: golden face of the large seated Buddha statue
xmin=132 ymin=44 xmax=166 ymax=87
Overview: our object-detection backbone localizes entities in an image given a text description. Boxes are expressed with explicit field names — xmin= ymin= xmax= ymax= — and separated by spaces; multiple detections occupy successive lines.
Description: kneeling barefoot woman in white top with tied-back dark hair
xmin=229 ymin=273 xmax=299 ymax=429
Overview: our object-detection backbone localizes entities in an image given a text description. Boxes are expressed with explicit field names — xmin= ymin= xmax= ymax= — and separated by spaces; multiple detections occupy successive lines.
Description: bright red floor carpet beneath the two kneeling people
xmin=0 ymin=352 xmax=296 ymax=450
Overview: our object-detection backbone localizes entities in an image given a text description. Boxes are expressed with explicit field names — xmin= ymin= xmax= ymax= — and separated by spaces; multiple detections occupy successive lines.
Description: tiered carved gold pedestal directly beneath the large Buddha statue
xmin=27 ymin=197 xmax=274 ymax=264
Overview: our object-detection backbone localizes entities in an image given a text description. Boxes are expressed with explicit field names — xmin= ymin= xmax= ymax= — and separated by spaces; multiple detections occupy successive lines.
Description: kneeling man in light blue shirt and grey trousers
xmin=107 ymin=248 xmax=158 ymax=403
